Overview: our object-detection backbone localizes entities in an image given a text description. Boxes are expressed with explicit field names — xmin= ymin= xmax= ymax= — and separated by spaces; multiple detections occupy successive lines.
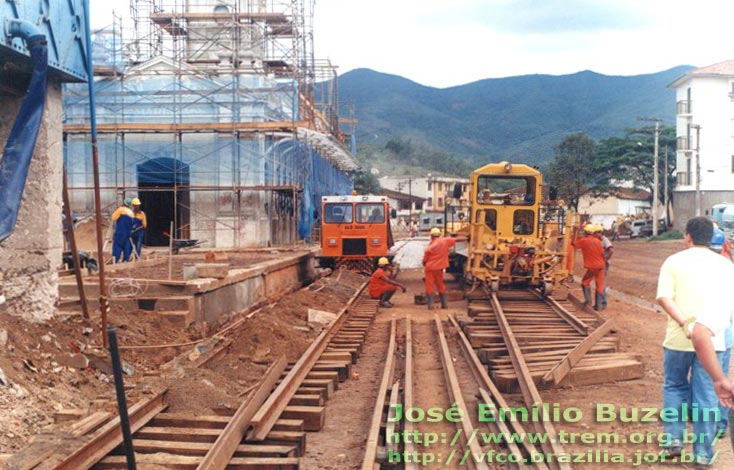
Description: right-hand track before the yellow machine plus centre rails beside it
xmin=362 ymin=284 xmax=642 ymax=470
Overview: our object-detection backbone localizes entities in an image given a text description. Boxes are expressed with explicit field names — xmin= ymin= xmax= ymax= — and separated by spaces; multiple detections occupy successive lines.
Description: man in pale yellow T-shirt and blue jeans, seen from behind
xmin=657 ymin=217 xmax=734 ymax=468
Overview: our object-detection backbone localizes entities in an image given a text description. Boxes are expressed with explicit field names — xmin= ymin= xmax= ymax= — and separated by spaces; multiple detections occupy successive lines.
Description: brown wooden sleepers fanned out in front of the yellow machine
xmin=463 ymin=290 xmax=644 ymax=392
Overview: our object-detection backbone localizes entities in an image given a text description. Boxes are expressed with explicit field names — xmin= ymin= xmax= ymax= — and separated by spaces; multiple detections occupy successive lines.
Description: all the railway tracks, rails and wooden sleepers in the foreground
xmin=11 ymin=253 xmax=642 ymax=470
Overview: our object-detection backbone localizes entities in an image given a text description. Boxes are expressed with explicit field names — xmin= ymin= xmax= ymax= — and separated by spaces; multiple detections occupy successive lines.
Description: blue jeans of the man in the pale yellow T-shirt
xmin=663 ymin=348 xmax=723 ymax=461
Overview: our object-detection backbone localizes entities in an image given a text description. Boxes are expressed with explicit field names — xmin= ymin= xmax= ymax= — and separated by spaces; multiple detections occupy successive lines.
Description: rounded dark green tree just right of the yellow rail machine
xmin=547 ymin=132 xmax=595 ymax=211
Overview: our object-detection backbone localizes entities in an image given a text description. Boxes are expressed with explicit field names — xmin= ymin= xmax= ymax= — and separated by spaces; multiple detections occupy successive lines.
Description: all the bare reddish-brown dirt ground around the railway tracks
xmin=0 ymin=240 xmax=734 ymax=470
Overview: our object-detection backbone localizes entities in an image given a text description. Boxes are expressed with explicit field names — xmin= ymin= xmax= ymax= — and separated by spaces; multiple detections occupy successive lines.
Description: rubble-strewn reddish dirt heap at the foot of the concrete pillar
xmin=0 ymin=302 xmax=195 ymax=453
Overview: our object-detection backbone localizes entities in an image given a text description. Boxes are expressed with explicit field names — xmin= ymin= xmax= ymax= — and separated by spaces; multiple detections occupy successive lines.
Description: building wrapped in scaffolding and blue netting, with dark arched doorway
xmin=64 ymin=0 xmax=358 ymax=247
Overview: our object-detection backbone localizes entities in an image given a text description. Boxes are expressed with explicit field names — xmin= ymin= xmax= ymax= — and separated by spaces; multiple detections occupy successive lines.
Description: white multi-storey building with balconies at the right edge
xmin=668 ymin=60 xmax=734 ymax=230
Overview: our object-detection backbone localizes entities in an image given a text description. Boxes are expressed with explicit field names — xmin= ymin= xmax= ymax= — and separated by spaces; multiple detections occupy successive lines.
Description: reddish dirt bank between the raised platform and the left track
xmin=0 ymin=264 xmax=364 ymax=454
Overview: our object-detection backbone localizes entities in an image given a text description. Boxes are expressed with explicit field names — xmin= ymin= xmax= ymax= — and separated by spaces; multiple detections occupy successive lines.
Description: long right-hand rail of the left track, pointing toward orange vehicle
xmin=247 ymin=282 xmax=368 ymax=441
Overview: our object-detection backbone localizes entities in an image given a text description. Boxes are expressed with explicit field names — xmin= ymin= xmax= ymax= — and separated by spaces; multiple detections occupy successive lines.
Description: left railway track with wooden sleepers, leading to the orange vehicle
xmin=10 ymin=276 xmax=377 ymax=470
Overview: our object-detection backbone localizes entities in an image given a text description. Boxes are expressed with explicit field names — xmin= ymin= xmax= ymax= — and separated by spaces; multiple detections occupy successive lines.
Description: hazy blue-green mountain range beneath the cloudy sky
xmin=339 ymin=65 xmax=693 ymax=169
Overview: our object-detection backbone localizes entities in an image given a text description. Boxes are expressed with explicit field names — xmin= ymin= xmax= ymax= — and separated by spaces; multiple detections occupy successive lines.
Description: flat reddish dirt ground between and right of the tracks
xmin=303 ymin=240 xmax=734 ymax=470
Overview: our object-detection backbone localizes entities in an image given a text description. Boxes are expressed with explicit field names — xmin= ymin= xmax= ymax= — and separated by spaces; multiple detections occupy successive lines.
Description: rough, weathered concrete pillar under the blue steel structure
xmin=0 ymin=83 xmax=63 ymax=321
